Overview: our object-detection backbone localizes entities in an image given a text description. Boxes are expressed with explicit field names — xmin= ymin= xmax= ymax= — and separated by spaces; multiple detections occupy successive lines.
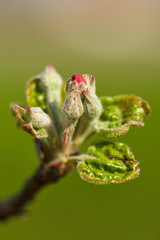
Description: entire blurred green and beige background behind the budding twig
xmin=0 ymin=0 xmax=160 ymax=240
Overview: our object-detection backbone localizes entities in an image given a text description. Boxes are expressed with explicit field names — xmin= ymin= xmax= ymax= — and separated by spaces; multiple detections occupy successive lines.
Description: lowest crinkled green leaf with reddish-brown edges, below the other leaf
xmin=78 ymin=142 xmax=140 ymax=184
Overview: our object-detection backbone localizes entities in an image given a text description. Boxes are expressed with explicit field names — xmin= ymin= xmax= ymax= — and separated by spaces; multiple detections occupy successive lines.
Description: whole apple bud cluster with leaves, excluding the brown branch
xmin=11 ymin=65 xmax=150 ymax=184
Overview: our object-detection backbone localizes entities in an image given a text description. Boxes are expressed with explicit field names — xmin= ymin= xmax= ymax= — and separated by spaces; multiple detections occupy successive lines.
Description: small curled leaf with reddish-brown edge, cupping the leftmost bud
xmin=11 ymin=104 xmax=48 ymax=138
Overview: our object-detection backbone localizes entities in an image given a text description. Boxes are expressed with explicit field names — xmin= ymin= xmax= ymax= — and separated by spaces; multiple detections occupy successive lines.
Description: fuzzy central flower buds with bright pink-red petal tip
xmin=63 ymin=74 xmax=102 ymax=122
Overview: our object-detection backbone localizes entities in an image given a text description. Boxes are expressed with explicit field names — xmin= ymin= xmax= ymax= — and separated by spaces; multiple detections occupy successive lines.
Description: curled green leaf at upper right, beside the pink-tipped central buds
xmin=95 ymin=95 xmax=151 ymax=139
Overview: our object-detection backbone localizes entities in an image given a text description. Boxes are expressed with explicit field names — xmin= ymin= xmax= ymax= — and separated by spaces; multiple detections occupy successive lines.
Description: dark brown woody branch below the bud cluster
xmin=0 ymin=165 xmax=73 ymax=221
